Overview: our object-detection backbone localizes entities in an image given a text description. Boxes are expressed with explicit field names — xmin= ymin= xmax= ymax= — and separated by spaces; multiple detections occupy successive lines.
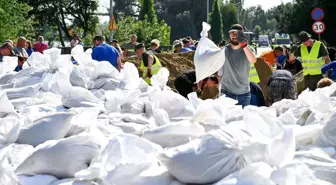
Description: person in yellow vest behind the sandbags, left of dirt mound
xmin=135 ymin=43 xmax=162 ymax=85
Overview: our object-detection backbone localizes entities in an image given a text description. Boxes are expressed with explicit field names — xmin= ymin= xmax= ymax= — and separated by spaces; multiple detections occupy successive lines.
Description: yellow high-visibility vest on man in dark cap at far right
xmin=301 ymin=41 xmax=325 ymax=76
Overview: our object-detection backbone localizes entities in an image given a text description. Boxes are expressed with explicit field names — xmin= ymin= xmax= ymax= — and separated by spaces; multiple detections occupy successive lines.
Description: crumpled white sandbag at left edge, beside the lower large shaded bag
xmin=0 ymin=144 xmax=34 ymax=169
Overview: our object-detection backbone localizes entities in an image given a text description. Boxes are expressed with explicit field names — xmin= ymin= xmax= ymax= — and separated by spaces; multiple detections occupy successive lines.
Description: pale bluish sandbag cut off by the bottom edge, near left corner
xmin=18 ymin=175 xmax=58 ymax=185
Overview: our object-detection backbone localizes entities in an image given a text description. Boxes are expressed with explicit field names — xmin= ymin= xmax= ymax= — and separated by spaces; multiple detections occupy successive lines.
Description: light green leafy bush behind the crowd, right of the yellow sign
xmin=112 ymin=17 xmax=170 ymax=45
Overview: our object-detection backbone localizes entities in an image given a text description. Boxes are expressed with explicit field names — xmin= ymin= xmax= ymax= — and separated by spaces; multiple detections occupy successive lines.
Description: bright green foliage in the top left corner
xmin=0 ymin=0 xmax=34 ymax=45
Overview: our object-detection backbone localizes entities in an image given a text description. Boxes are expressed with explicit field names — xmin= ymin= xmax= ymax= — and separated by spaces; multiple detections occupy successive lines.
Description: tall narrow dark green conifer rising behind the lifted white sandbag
xmin=209 ymin=0 xmax=224 ymax=43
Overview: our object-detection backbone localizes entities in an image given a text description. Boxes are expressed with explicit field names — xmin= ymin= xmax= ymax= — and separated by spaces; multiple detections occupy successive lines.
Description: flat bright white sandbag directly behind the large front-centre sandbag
xmin=142 ymin=121 xmax=205 ymax=148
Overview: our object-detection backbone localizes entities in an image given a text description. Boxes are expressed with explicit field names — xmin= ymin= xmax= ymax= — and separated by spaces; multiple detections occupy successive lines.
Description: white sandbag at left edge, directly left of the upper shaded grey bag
xmin=0 ymin=116 xmax=22 ymax=145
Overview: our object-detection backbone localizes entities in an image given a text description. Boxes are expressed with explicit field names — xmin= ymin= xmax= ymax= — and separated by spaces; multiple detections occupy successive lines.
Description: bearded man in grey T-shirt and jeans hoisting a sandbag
xmin=218 ymin=24 xmax=257 ymax=107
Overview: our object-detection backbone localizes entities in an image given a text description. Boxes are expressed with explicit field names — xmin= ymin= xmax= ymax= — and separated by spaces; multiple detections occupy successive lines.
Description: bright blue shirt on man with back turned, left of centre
xmin=92 ymin=43 xmax=119 ymax=68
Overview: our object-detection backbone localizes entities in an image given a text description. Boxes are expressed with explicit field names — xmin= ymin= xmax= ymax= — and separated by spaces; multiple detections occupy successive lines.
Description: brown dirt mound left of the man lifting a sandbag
xmin=124 ymin=52 xmax=195 ymax=88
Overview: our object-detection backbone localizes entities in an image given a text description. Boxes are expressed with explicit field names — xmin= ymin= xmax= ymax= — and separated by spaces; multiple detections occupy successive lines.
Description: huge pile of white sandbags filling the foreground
xmin=0 ymin=26 xmax=336 ymax=185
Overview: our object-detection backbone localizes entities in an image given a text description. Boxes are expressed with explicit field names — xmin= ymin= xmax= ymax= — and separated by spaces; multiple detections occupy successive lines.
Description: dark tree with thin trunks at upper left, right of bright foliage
xmin=27 ymin=0 xmax=99 ymax=46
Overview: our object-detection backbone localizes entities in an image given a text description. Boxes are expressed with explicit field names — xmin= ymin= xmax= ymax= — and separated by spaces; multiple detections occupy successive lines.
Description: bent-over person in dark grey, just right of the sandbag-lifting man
xmin=267 ymin=70 xmax=296 ymax=106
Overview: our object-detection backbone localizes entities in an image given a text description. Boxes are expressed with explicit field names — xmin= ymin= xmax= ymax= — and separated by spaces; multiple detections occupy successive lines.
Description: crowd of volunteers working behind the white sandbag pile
xmin=0 ymin=24 xmax=336 ymax=107
